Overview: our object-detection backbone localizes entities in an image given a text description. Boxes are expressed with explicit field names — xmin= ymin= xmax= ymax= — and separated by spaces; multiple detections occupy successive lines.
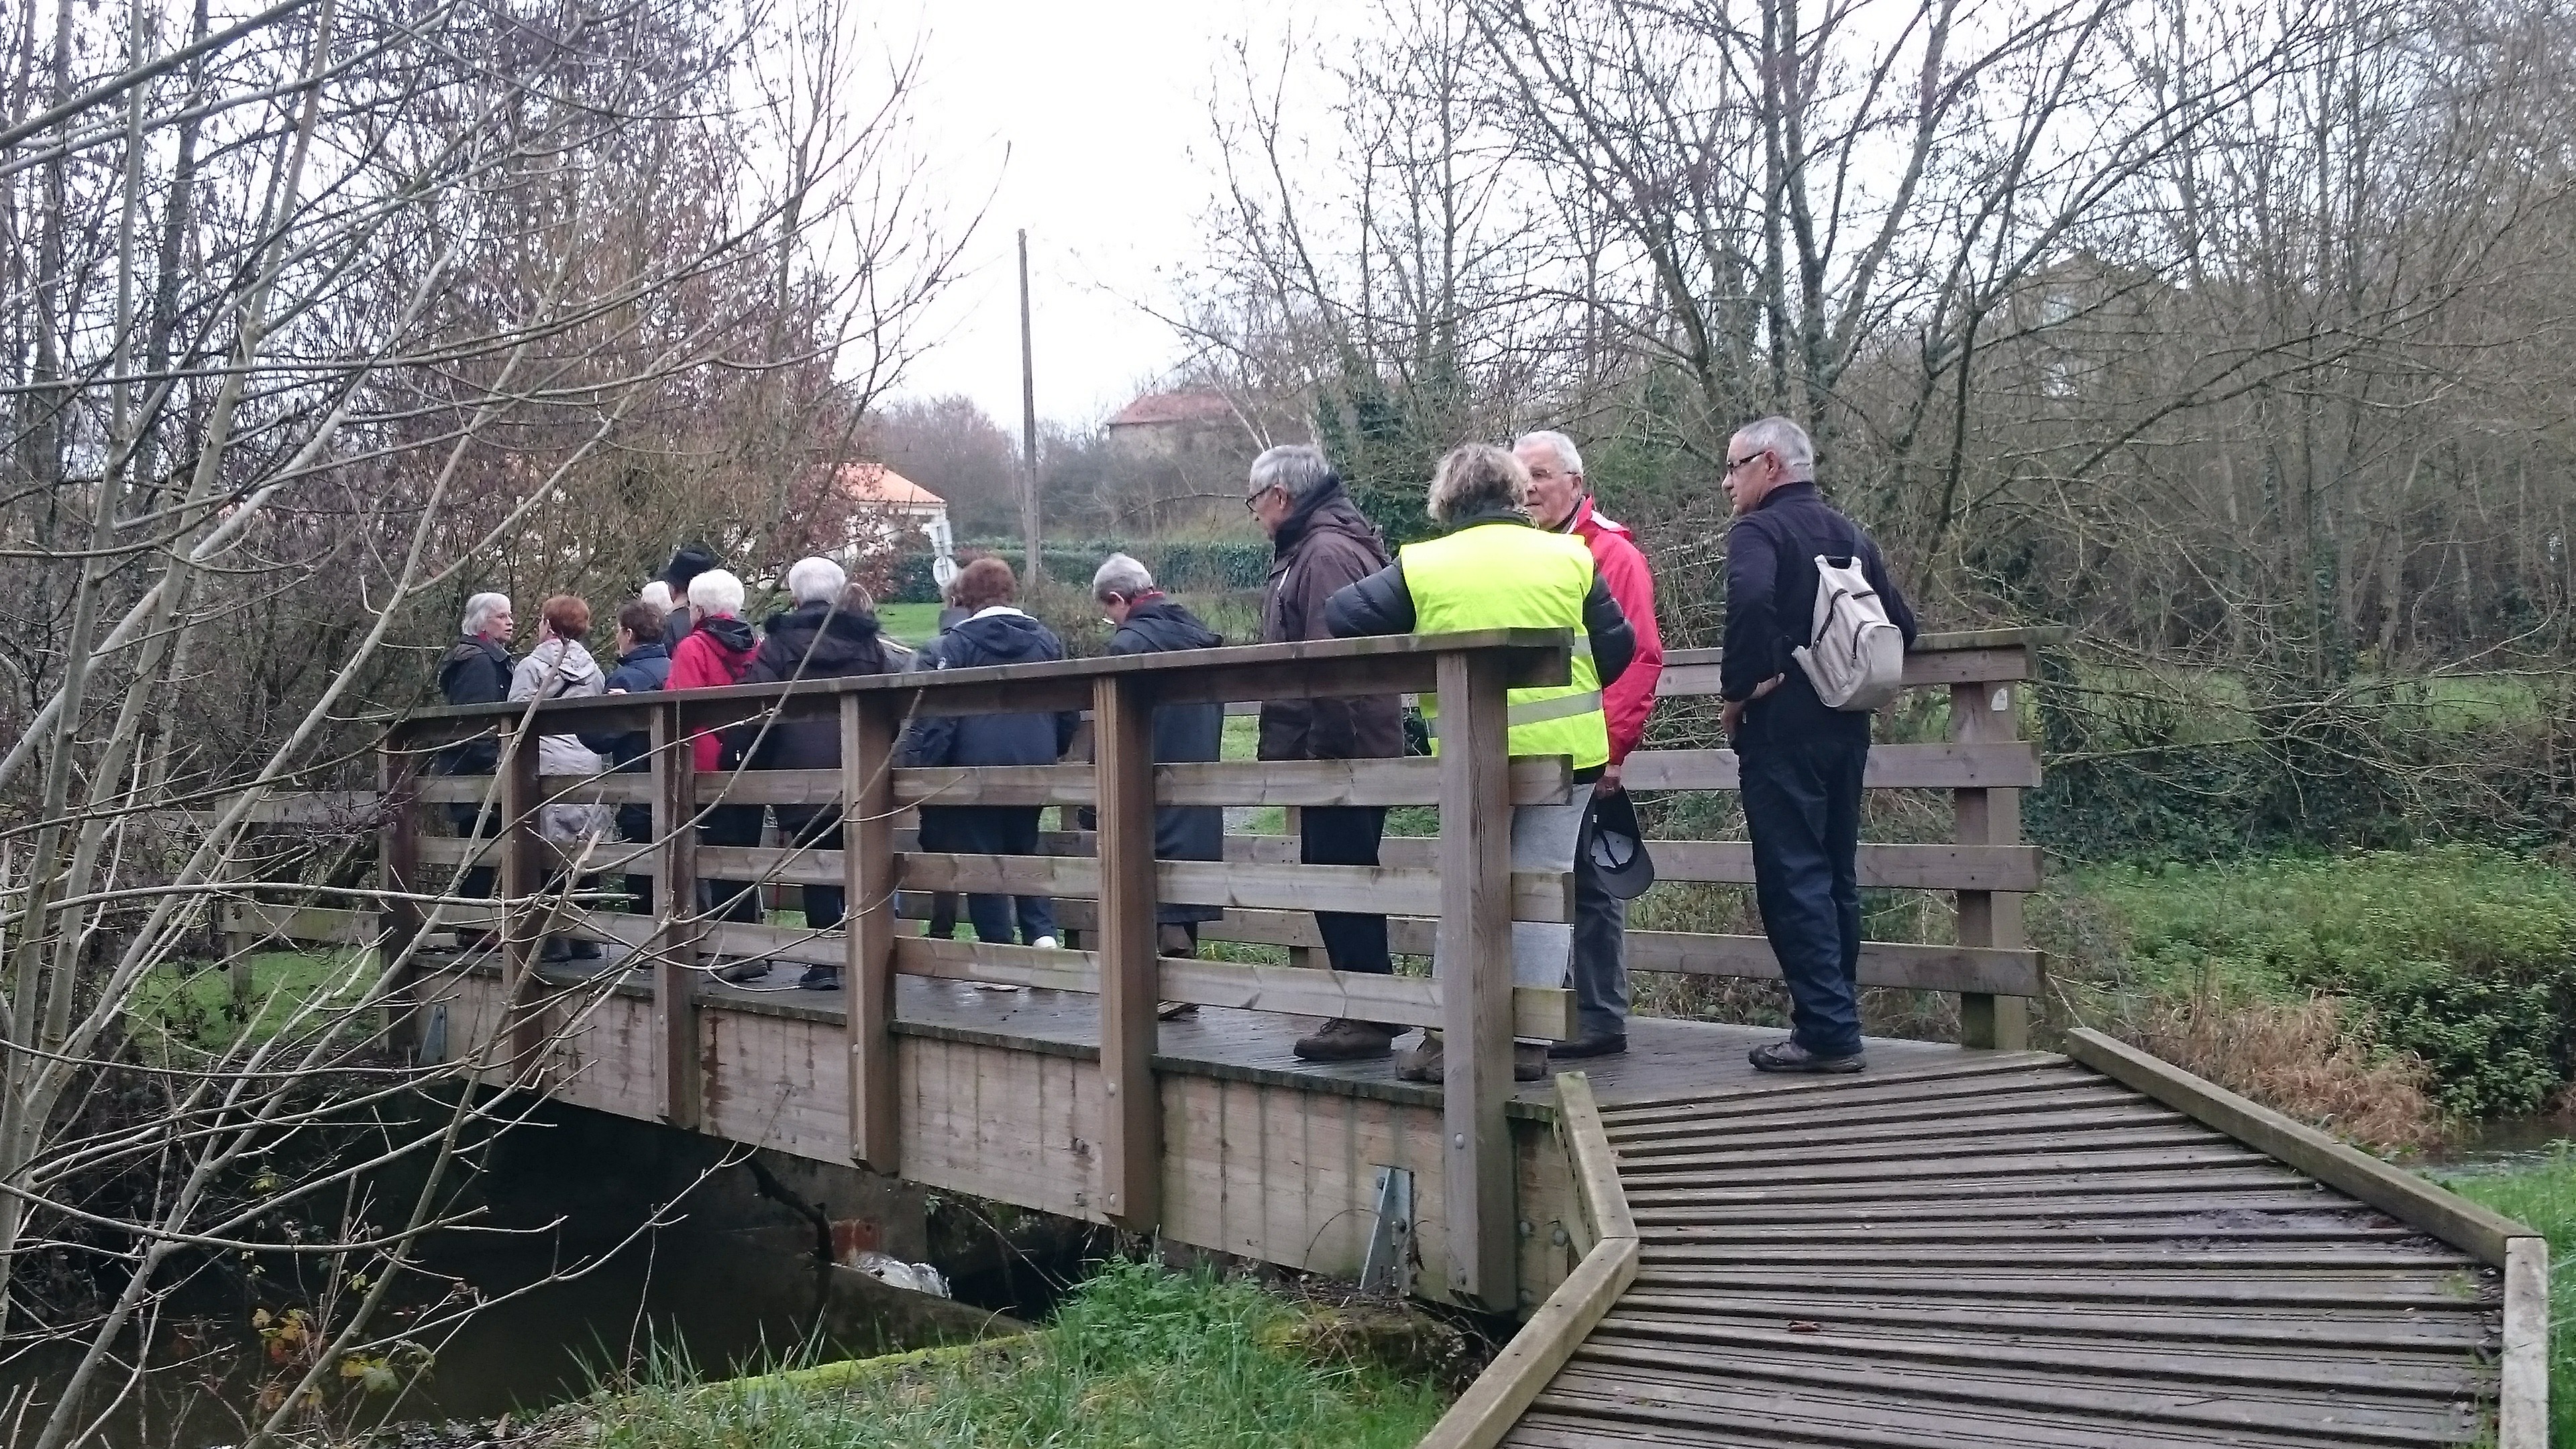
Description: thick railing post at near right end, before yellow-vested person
xmin=1435 ymin=652 xmax=1520 ymax=1312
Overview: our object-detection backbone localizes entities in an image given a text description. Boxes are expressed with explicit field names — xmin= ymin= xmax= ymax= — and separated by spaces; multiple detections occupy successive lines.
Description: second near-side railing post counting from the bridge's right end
xmin=1092 ymin=676 xmax=1162 ymax=1232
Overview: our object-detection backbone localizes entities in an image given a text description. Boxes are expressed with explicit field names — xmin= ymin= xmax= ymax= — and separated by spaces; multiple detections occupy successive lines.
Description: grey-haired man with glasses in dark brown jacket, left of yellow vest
xmin=1244 ymin=443 xmax=1404 ymax=1062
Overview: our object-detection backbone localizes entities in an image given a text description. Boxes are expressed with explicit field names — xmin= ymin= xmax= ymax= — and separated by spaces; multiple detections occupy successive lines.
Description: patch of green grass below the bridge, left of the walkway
xmin=595 ymin=1263 xmax=1442 ymax=1449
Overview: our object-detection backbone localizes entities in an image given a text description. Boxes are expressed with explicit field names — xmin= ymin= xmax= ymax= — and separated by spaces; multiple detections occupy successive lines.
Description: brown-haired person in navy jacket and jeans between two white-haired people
xmin=902 ymin=559 xmax=1082 ymax=947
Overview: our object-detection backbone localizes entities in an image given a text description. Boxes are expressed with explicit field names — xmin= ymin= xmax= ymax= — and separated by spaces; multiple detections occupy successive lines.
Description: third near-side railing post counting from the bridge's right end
xmin=840 ymin=691 xmax=902 ymax=1173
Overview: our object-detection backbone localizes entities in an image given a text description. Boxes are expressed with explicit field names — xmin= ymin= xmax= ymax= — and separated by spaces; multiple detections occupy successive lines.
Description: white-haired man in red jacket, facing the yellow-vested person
xmin=1512 ymin=433 xmax=1664 ymax=1057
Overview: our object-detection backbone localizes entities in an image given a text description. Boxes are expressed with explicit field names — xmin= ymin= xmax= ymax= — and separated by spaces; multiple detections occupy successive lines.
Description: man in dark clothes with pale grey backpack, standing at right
xmin=1718 ymin=418 xmax=1914 ymax=1073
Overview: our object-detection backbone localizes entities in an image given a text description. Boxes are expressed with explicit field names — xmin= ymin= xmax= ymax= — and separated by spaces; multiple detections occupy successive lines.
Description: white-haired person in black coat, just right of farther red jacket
xmin=737 ymin=559 xmax=886 ymax=990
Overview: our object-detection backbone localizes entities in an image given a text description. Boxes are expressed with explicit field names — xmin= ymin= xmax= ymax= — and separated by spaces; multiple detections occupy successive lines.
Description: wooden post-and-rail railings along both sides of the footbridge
xmin=206 ymin=621 xmax=2043 ymax=1302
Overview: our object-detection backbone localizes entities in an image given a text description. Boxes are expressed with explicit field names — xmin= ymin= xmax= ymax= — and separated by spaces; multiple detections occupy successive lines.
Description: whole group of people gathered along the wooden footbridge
xmin=441 ymin=407 xmax=1914 ymax=1080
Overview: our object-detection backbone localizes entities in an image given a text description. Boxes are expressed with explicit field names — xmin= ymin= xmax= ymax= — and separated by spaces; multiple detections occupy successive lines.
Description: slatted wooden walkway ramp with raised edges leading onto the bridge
xmin=1425 ymin=1042 xmax=2545 ymax=1449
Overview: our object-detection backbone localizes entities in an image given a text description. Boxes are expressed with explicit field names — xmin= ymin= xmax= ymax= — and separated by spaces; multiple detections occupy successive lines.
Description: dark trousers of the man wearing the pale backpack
xmin=1736 ymin=737 xmax=1870 ymax=1057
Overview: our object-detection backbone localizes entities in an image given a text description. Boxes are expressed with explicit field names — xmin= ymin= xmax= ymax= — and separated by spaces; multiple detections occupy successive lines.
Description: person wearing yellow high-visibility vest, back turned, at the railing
xmin=1324 ymin=443 xmax=1635 ymax=1080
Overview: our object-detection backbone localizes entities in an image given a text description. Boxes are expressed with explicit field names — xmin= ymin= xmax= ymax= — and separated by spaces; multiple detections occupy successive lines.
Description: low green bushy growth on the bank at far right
xmin=2086 ymin=846 xmax=2576 ymax=1116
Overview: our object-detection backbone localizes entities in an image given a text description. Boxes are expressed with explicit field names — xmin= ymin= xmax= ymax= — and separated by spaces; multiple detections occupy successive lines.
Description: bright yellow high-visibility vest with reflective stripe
xmin=1399 ymin=523 xmax=1610 ymax=771
